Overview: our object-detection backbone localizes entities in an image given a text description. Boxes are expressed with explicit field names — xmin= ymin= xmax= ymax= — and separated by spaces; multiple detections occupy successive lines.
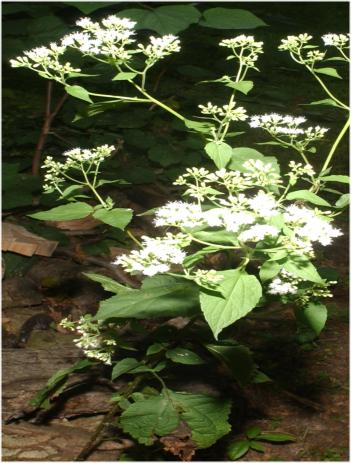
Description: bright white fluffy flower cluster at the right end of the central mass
xmin=283 ymin=204 xmax=342 ymax=247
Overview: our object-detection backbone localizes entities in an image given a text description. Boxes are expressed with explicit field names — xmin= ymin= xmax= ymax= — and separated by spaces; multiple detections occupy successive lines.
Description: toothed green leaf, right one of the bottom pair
xmin=171 ymin=392 xmax=231 ymax=449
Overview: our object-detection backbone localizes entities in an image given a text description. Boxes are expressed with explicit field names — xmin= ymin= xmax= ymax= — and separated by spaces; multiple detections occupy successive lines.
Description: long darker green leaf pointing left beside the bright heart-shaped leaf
xmin=96 ymin=275 xmax=199 ymax=320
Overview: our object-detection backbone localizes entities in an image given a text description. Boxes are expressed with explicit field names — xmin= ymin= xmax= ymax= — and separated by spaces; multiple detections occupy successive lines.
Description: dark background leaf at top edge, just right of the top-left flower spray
xmin=118 ymin=5 xmax=201 ymax=35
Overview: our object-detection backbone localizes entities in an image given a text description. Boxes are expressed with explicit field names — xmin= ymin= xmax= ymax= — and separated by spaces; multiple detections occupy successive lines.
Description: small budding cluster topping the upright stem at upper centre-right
xmin=219 ymin=34 xmax=263 ymax=67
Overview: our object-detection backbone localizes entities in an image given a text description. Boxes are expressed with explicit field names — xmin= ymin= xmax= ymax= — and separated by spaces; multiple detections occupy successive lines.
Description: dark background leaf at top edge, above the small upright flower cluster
xmin=200 ymin=7 xmax=267 ymax=29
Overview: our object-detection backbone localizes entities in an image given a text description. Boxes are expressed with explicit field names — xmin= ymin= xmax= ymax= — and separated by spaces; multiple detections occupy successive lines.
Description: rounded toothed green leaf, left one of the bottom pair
xmin=119 ymin=394 xmax=180 ymax=445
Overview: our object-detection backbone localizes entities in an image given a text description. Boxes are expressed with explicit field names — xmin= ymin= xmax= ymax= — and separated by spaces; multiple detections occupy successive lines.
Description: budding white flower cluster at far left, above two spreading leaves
xmin=42 ymin=145 xmax=115 ymax=191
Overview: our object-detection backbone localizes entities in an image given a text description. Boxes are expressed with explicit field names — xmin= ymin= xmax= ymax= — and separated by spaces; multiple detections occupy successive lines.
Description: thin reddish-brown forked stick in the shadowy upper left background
xmin=32 ymin=81 xmax=68 ymax=175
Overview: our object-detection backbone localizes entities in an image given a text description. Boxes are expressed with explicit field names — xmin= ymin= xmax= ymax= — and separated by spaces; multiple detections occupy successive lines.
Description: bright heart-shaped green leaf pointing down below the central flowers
xmin=200 ymin=269 xmax=262 ymax=339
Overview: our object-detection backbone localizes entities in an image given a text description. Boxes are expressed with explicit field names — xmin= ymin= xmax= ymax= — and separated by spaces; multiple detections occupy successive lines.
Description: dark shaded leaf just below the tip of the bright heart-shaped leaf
xmin=205 ymin=344 xmax=255 ymax=386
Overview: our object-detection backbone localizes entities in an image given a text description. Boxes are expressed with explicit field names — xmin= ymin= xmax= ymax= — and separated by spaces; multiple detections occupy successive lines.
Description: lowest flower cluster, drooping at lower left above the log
xmin=60 ymin=315 xmax=117 ymax=365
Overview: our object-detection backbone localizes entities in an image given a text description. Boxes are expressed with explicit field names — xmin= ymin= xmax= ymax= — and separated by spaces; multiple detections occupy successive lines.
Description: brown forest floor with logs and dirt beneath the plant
xmin=2 ymin=216 xmax=349 ymax=461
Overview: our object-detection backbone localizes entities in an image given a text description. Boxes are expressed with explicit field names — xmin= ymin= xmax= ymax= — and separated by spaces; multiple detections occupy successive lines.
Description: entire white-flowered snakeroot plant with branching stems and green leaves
xmin=11 ymin=19 xmax=349 ymax=460
